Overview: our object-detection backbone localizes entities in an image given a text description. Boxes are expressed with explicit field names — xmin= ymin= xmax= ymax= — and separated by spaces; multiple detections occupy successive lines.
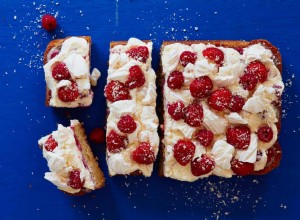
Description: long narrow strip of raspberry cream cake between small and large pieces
xmin=105 ymin=38 xmax=159 ymax=176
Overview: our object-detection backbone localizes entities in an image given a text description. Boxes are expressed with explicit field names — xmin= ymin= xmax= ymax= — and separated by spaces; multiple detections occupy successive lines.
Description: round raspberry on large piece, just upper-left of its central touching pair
xmin=190 ymin=76 xmax=213 ymax=99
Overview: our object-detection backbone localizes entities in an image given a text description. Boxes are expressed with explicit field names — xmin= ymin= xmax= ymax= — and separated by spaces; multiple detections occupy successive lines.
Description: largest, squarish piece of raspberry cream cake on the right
xmin=160 ymin=40 xmax=284 ymax=181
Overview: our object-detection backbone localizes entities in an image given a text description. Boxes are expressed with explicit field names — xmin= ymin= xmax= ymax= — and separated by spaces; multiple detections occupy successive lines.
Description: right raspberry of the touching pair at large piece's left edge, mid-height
xmin=183 ymin=103 xmax=203 ymax=127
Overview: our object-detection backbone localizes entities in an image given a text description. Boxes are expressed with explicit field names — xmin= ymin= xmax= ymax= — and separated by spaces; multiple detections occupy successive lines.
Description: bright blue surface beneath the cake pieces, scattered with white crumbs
xmin=0 ymin=0 xmax=300 ymax=219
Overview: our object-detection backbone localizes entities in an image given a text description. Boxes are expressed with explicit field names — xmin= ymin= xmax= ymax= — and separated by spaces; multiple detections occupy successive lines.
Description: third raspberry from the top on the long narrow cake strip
xmin=104 ymin=80 xmax=130 ymax=102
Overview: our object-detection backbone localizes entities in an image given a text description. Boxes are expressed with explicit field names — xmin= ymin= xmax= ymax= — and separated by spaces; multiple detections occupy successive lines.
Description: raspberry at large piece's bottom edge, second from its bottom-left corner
xmin=191 ymin=154 xmax=215 ymax=176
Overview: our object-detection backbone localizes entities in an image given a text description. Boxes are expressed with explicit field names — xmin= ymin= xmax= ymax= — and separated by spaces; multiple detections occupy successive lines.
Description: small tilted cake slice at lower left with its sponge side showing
xmin=38 ymin=120 xmax=105 ymax=195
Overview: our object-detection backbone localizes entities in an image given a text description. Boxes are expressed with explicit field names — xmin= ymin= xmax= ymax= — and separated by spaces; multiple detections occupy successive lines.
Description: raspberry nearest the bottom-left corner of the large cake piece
xmin=173 ymin=139 xmax=196 ymax=166
